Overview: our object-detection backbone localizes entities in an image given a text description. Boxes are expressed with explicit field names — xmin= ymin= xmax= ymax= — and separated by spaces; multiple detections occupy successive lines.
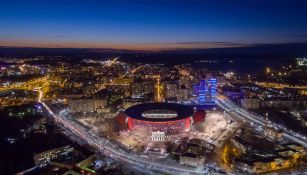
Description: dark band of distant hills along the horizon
xmin=0 ymin=43 xmax=307 ymax=61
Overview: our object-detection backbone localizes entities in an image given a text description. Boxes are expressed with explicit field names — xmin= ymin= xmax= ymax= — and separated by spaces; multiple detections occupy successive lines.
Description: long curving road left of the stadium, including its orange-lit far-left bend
xmin=0 ymin=76 xmax=229 ymax=174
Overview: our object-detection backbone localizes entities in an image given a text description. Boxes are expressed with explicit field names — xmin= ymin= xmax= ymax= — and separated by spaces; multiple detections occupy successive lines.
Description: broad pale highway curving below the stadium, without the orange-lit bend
xmin=39 ymin=99 xmax=212 ymax=174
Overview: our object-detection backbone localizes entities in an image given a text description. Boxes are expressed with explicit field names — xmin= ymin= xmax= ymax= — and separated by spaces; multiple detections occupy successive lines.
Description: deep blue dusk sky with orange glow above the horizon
xmin=0 ymin=0 xmax=307 ymax=50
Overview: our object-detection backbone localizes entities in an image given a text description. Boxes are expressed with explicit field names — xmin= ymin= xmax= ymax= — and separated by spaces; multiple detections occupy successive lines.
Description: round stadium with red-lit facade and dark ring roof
xmin=118 ymin=103 xmax=203 ymax=133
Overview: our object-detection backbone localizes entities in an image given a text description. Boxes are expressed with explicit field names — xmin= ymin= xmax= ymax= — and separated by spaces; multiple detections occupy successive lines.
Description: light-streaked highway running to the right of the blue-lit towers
xmin=216 ymin=95 xmax=307 ymax=148
